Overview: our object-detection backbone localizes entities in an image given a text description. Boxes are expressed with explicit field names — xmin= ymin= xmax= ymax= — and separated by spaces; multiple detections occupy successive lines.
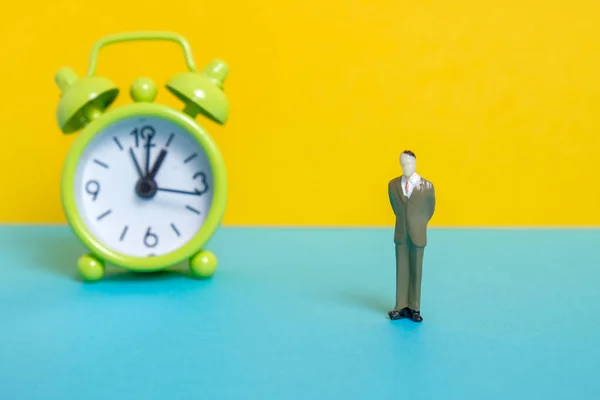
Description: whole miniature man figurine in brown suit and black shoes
xmin=388 ymin=150 xmax=435 ymax=322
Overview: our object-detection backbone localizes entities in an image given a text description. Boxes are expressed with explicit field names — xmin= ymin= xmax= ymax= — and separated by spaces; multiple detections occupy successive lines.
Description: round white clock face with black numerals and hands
xmin=74 ymin=117 xmax=213 ymax=257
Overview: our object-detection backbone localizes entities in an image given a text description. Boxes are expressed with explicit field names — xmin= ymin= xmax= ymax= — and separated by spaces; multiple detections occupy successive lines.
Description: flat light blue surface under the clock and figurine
xmin=0 ymin=226 xmax=600 ymax=400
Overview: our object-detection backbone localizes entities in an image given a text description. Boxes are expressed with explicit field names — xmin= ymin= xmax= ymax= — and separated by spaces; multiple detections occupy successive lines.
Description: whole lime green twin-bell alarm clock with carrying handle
xmin=55 ymin=32 xmax=229 ymax=281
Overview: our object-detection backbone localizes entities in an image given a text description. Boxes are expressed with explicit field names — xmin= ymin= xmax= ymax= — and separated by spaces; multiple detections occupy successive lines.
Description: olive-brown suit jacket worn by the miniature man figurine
xmin=388 ymin=176 xmax=435 ymax=247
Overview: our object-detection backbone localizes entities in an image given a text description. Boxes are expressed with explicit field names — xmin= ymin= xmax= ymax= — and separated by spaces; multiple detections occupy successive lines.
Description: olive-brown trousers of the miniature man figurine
xmin=395 ymin=238 xmax=425 ymax=311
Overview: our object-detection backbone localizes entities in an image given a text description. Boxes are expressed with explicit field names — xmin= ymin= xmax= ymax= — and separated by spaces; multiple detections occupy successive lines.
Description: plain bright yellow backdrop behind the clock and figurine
xmin=0 ymin=0 xmax=600 ymax=226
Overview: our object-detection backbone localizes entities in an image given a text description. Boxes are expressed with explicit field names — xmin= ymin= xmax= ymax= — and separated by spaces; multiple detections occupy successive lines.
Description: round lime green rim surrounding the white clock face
xmin=61 ymin=103 xmax=227 ymax=272
